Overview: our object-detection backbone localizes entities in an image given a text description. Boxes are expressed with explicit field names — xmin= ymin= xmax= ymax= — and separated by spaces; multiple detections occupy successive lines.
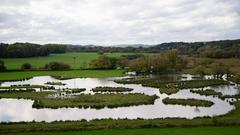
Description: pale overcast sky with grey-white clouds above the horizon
xmin=0 ymin=0 xmax=240 ymax=45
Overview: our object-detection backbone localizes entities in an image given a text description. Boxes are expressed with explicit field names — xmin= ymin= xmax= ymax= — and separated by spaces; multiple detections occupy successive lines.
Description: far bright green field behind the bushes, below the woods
xmin=2 ymin=52 xmax=148 ymax=69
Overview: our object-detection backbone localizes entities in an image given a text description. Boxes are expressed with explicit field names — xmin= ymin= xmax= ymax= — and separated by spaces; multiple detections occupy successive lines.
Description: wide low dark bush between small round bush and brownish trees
xmin=45 ymin=62 xmax=70 ymax=70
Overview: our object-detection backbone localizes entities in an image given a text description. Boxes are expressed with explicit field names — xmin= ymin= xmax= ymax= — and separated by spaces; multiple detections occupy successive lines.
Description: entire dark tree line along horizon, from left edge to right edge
xmin=0 ymin=39 xmax=240 ymax=58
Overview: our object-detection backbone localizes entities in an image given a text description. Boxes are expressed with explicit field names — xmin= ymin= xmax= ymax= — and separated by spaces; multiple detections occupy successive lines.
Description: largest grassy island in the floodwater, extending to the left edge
xmin=0 ymin=91 xmax=157 ymax=108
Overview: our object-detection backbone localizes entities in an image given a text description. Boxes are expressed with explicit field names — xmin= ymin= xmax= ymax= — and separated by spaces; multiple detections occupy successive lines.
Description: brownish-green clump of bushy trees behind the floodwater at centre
xmin=89 ymin=51 xmax=187 ymax=73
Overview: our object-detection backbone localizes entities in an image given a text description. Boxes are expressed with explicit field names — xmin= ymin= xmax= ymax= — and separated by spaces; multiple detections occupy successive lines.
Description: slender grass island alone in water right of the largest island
xmin=162 ymin=97 xmax=214 ymax=107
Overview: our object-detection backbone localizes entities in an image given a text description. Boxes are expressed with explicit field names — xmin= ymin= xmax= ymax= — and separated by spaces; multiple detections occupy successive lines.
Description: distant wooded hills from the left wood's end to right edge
xmin=67 ymin=39 xmax=240 ymax=58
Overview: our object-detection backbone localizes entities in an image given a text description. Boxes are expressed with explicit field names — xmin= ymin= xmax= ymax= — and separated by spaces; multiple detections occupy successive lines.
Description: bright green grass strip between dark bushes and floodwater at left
xmin=0 ymin=70 xmax=125 ymax=81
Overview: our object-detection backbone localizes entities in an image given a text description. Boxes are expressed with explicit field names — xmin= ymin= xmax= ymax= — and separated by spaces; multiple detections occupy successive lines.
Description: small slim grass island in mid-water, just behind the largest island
xmin=92 ymin=87 xmax=133 ymax=92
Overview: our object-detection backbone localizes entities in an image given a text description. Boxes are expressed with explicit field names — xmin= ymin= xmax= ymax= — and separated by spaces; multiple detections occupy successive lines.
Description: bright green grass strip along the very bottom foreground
xmin=5 ymin=126 xmax=240 ymax=135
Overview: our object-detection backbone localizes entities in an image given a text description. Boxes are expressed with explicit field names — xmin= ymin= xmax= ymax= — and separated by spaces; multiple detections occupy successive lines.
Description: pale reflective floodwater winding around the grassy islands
xmin=0 ymin=75 xmax=240 ymax=122
